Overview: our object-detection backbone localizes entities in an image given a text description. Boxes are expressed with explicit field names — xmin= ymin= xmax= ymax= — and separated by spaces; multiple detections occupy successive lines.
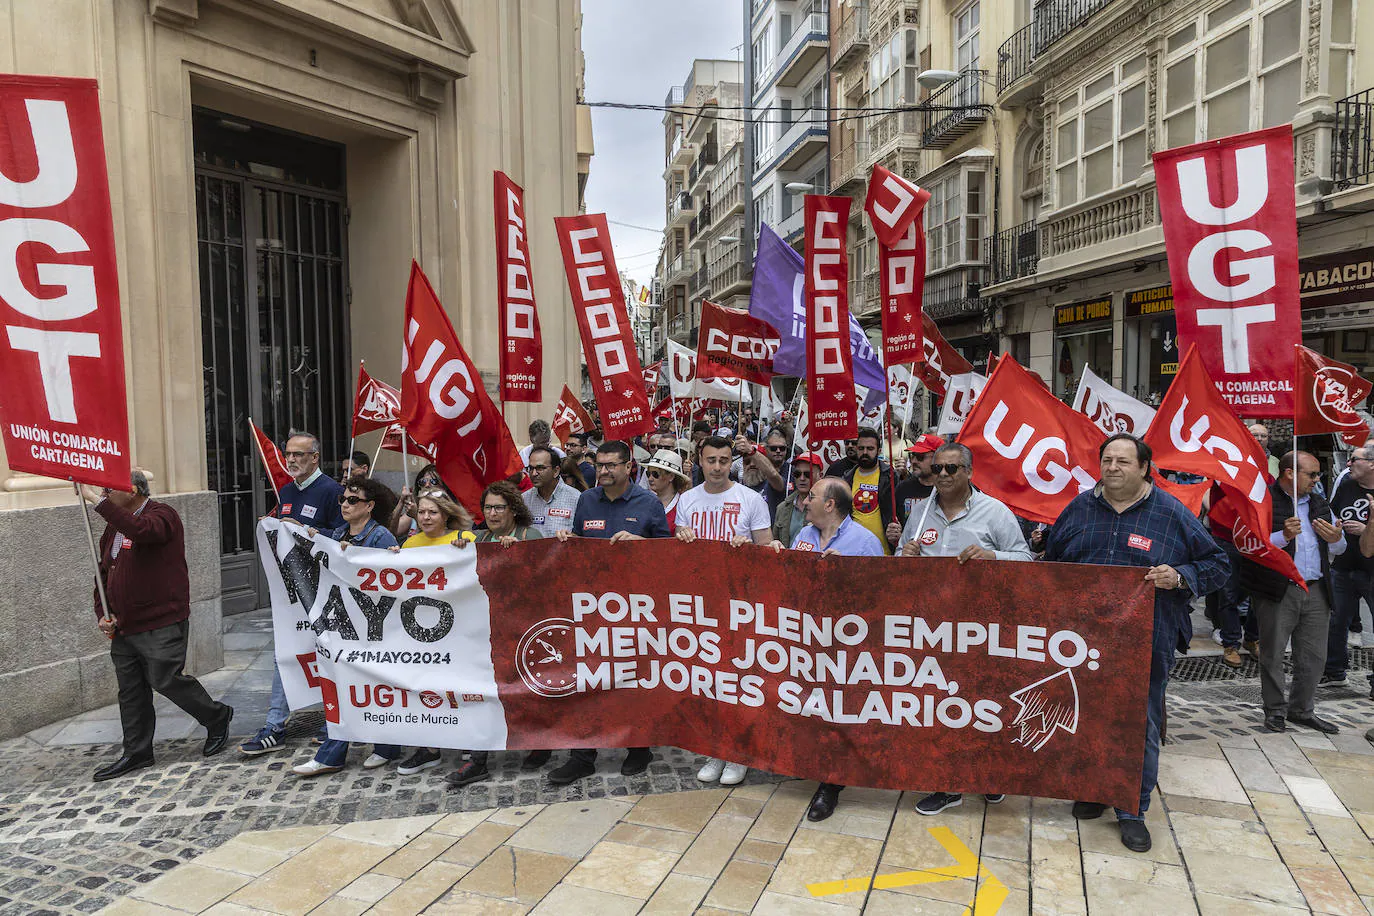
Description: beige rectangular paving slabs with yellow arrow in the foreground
xmin=104 ymin=717 xmax=1374 ymax=916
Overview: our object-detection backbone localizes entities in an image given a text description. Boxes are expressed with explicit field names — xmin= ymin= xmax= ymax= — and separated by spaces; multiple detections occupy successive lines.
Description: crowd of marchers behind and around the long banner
xmin=87 ymin=408 xmax=1374 ymax=851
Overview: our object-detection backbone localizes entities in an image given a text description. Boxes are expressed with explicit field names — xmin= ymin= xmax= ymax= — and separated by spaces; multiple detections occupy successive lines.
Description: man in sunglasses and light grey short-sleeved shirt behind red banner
xmin=897 ymin=442 xmax=1035 ymax=816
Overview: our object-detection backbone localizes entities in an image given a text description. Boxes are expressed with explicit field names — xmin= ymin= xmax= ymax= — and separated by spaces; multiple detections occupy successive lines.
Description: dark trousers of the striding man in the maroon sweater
xmin=110 ymin=621 xmax=229 ymax=757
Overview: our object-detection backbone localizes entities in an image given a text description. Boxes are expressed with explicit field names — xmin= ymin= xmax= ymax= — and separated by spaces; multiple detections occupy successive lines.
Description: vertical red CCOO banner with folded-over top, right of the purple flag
xmin=864 ymin=165 xmax=930 ymax=368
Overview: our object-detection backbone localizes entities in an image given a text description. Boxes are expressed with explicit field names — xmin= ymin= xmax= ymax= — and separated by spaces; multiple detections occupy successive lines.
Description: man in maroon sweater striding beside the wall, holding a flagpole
xmin=81 ymin=470 xmax=234 ymax=781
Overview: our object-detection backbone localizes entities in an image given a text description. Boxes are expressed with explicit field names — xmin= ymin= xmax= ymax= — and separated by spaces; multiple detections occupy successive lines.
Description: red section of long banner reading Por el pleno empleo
xmin=478 ymin=541 xmax=1154 ymax=810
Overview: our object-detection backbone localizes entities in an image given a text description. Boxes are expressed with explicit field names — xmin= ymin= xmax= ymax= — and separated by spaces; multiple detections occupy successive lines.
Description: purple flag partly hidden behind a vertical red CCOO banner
xmin=749 ymin=222 xmax=888 ymax=402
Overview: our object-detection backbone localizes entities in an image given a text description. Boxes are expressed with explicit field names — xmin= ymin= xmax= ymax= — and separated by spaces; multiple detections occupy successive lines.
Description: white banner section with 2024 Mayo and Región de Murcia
xmin=258 ymin=519 xmax=507 ymax=750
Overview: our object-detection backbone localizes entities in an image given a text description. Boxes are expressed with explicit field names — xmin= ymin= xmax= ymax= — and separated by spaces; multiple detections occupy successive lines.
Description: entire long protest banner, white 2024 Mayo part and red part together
xmin=258 ymin=519 xmax=1154 ymax=810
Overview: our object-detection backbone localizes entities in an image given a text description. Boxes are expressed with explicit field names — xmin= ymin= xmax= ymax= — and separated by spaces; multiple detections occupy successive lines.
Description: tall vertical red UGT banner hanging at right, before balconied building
xmin=1154 ymin=124 xmax=1303 ymax=417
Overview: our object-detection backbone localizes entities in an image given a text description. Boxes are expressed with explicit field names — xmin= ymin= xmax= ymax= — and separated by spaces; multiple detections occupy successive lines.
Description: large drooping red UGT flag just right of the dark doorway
xmin=400 ymin=261 xmax=521 ymax=516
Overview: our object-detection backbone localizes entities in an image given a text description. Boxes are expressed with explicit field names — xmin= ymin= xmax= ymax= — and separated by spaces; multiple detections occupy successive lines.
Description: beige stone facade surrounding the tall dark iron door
xmin=0 ymin=0 xmax=580 ymax=511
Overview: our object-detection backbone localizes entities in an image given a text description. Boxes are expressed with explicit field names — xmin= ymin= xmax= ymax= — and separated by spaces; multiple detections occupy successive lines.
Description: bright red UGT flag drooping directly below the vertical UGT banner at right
xmin=1143 ymin=345 xmax=1307 ymax=588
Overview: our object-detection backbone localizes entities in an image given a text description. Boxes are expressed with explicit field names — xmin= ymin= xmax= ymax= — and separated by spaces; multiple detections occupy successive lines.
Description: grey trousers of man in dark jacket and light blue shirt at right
xmin=1250 ymin=580 xmax=1345 ymax=718
